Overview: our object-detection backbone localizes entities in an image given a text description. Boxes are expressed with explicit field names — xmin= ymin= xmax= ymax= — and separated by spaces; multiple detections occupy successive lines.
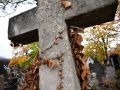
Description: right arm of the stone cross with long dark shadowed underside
xmin=65 ymin=0 xmax=118 ymax=27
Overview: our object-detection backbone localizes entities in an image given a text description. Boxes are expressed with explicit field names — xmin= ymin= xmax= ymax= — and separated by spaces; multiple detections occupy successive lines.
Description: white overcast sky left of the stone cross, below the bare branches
xmin=0 ymin=4 xmax=35 ymax=58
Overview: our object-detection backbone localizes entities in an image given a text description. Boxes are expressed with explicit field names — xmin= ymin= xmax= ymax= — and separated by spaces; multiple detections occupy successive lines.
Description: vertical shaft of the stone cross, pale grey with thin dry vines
xmin=38 ymin=0 xmax=80 ymax=90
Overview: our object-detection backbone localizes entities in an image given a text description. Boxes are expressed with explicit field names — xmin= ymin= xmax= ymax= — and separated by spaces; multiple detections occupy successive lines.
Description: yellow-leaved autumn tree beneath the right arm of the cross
xmin=84 ymin=22 xmax=118 ymax=61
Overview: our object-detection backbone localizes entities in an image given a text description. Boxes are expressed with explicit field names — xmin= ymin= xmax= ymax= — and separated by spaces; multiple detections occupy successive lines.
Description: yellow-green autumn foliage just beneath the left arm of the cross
xmin=9 ymin=42 xmax=39 ymax=67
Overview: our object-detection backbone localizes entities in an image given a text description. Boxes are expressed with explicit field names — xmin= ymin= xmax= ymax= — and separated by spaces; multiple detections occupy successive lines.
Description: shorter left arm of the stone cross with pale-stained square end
xmin=8 ymin=8 xmax=38 ymax=44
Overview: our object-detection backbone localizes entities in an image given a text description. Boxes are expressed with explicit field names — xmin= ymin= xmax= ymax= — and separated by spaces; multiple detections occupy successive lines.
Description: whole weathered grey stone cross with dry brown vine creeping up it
xmin=8 ymin=0 xmax=117 ymax=90
